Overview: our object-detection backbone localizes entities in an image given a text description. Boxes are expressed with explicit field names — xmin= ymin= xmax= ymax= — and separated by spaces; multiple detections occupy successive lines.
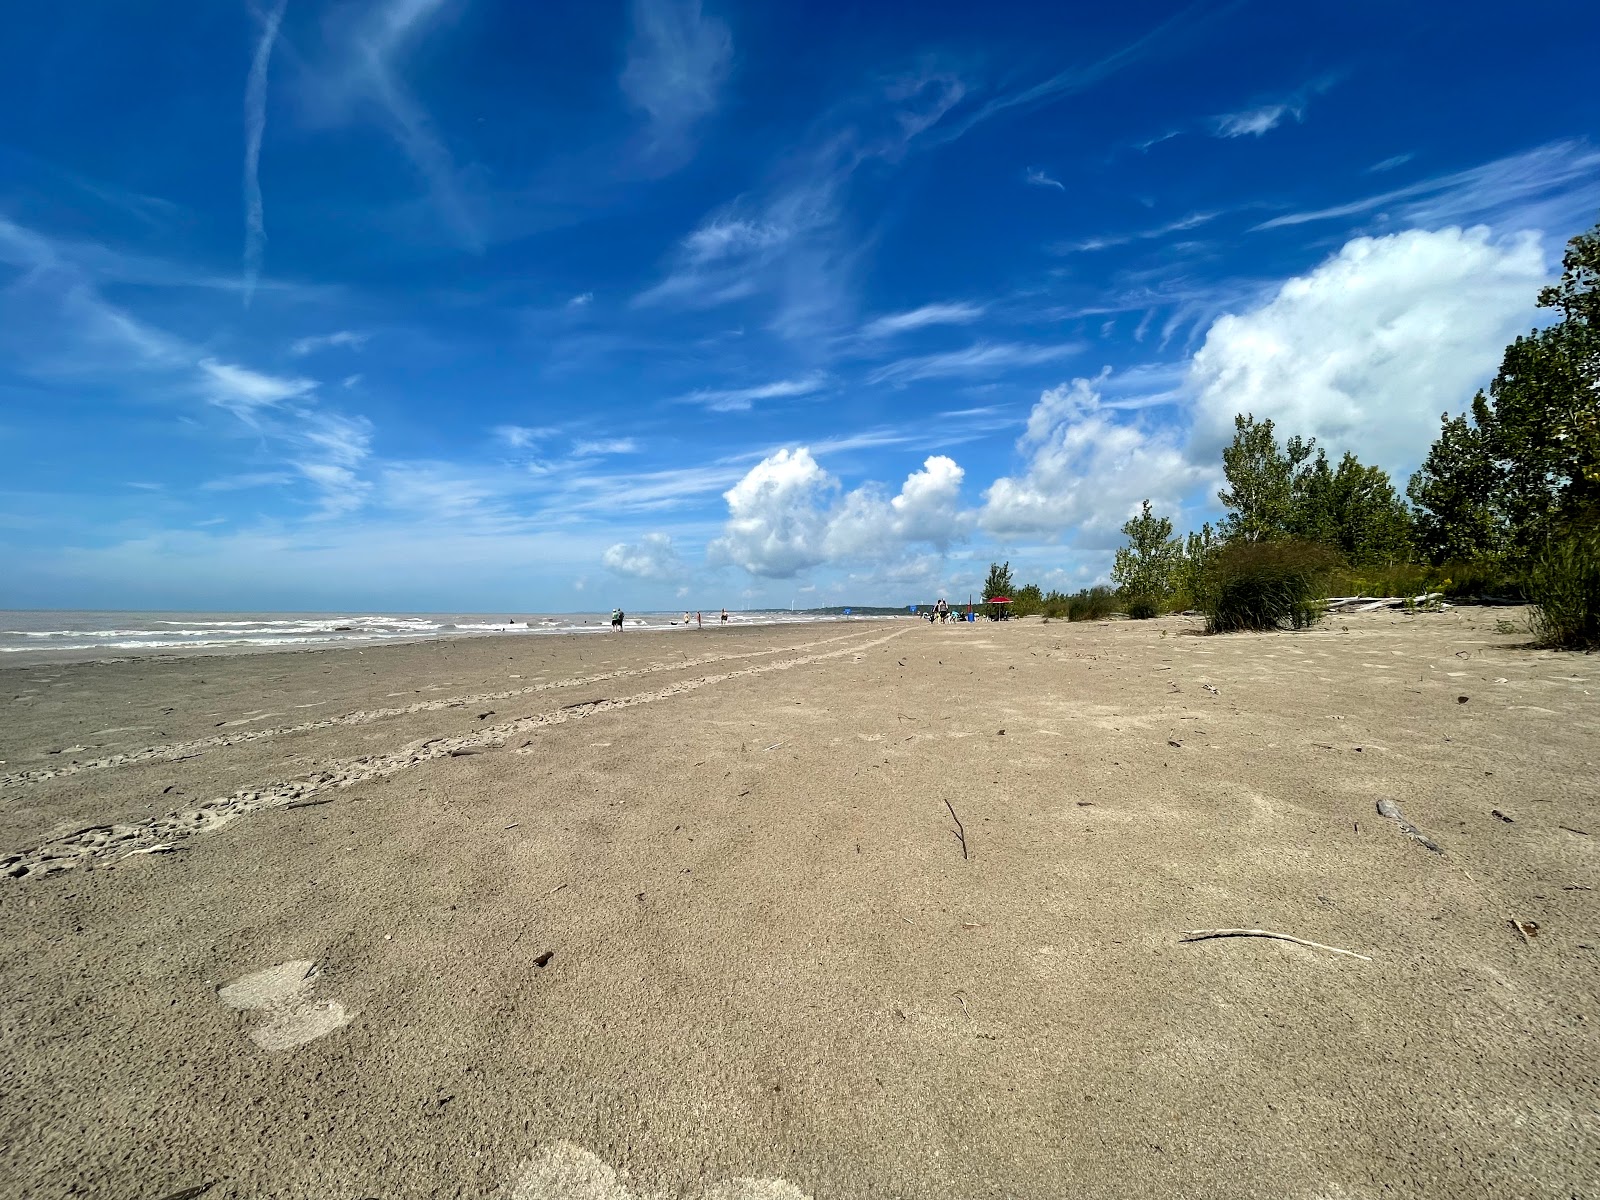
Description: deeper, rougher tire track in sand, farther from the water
xmin=0 ymin=629 xmax=910 ymax=878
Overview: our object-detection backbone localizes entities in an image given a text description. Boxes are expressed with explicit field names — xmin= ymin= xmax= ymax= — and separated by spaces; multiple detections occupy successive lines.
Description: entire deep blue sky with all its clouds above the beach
xmin=0 ymin=0 xmax=1600 ymax=611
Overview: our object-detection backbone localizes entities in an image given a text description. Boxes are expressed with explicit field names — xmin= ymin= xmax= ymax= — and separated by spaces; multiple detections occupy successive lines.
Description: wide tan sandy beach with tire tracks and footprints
xmin=0 ymin=610 xmax=1600 ymax=1200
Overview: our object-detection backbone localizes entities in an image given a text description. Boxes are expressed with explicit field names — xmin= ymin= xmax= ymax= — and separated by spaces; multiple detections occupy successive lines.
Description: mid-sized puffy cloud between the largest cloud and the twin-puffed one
xmin=979 ymin=373 xmax=1203 ymax=539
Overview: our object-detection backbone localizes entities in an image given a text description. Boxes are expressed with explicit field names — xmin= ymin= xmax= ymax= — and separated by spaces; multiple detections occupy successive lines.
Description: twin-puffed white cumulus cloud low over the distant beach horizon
xmin=707 ymin=446 xmax=971 ymax=579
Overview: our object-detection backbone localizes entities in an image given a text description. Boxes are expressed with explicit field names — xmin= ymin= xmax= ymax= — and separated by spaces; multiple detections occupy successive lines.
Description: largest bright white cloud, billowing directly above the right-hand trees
xmin=1190 ymin=226 xmax=1546 ymax=472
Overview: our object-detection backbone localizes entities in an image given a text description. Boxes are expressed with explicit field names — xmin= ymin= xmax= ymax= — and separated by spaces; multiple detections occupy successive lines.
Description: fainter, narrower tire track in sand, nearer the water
xmin=0 ymin=629 xmax=872 ymax=789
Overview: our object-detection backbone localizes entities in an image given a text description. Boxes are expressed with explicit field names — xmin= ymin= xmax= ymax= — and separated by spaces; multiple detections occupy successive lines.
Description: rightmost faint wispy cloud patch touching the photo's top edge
xmin=618 ymin=0 xmax=733 ymax=157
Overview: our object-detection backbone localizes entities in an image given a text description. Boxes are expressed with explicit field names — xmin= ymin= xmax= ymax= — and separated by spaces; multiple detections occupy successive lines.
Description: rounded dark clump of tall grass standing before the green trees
xmin=1197 ymin=541 xmax=1339 ymax=634
